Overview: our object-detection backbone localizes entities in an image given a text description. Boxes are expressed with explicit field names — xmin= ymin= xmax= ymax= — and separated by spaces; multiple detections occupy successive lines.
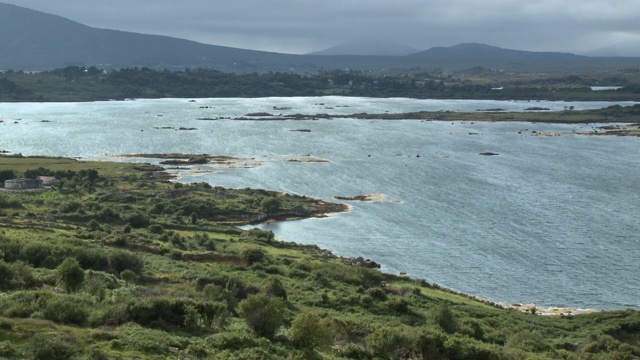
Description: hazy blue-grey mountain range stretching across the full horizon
xmin=0 ymin=3 xmax=639 ymax=72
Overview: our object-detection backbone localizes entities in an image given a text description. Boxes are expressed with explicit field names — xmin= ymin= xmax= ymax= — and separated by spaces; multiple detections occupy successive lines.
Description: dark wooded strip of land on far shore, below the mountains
xmin=0 ymin=66 xmax=640 ymax=101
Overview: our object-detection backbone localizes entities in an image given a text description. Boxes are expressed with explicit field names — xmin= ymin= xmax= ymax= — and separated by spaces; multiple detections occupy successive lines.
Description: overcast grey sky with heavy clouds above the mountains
xmin=0 ymin=0 xmax=640 ymax=53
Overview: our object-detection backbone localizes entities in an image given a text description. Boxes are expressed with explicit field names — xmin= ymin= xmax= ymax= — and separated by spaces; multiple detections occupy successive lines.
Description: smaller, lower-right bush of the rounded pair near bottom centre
xmin=291 ymin=311 xmax=333 ymax=350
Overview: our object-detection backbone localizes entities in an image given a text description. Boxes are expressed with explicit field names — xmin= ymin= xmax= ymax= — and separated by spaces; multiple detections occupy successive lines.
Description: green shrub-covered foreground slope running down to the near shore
xmin=0 ymin=157 xmax=640 ymax=359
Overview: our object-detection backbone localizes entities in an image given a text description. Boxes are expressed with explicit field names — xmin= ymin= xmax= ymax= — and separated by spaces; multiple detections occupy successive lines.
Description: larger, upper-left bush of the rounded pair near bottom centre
xmin=238 ymin=294 xmax=285 ymax=340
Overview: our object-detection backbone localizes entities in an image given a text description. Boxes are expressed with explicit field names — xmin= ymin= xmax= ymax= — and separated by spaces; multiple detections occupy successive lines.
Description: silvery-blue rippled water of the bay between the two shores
xmin=0 ymin=97 xmax=640 ymax=309
